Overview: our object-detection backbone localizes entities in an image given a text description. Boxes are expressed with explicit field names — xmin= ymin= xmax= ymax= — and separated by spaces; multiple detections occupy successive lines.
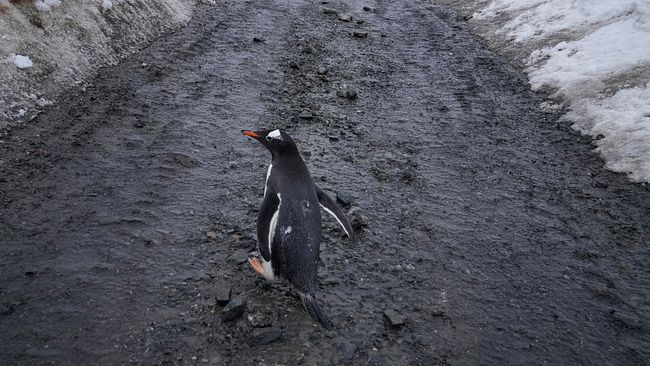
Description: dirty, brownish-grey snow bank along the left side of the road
xmin=0 ymin=0 xmax=195 ymax=128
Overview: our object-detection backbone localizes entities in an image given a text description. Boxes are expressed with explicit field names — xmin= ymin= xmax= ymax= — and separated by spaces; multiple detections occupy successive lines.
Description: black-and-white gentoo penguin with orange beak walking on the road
xmin=242 ymin=129 xmax=352 ymax=328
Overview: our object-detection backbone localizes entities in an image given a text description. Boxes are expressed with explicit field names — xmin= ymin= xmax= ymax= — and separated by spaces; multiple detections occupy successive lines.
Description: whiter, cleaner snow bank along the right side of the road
xmin=448 ymin=0 xmax=650 ymax=182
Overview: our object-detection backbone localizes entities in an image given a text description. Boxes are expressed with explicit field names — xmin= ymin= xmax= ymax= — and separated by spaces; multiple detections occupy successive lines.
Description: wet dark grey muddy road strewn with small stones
xmin=0 ymin=1 xmax=650 ymax=365
